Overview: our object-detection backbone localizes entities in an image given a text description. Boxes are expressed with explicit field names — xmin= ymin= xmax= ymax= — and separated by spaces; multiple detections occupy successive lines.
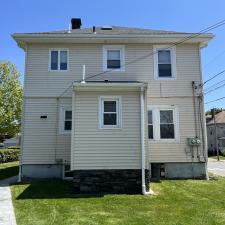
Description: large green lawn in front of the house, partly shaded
xmin=11 ymin=178 xmax=225 ymax=225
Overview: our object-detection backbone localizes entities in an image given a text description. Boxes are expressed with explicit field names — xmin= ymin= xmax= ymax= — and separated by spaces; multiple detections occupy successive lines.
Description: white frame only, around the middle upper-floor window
xmin=103 ymin=45 xmax=125 ymax=72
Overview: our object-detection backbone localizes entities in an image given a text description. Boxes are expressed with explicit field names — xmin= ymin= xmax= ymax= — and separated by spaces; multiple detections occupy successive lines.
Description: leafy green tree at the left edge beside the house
xmin=0 ymin=62 xmax=23 ymax=142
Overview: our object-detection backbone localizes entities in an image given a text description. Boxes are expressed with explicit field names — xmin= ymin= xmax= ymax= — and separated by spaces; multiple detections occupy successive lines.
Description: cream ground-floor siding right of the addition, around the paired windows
xmin=147 ymin=97 xmax=203 ymax=163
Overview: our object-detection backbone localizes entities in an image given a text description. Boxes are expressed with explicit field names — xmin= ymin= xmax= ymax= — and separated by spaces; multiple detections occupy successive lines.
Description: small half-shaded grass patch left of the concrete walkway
xmin=0 ymin=161 xmax=19 ymax=180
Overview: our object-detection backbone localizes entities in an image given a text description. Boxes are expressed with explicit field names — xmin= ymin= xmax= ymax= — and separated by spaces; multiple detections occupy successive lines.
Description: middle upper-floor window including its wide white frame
xmin=103 ymin=45 xmax=125 ymax=71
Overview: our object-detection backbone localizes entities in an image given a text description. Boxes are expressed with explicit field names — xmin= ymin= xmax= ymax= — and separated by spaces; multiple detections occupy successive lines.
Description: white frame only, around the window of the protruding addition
xmin=99 ymin=96 xmax=122 ymax=129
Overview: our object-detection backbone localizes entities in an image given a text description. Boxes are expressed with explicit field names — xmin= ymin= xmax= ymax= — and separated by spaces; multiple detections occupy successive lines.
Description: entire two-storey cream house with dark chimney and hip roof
xmin=13 ymin=19 xmax=213 ymax=192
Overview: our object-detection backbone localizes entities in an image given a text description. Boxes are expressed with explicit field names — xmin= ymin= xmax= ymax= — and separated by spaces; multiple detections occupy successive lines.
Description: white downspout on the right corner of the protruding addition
xmin=140 ymin=87 xmax=153 ymax=195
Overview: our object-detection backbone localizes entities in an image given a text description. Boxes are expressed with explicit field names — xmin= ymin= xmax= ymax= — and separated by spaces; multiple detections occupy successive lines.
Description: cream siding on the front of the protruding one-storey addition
xmin=71 ymin=91 xmax=141 ymax=169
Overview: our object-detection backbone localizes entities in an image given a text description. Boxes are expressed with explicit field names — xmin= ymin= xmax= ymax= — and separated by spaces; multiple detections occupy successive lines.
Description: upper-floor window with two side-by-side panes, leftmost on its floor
xmin=49 ymin=49 xmax=68 ymax=71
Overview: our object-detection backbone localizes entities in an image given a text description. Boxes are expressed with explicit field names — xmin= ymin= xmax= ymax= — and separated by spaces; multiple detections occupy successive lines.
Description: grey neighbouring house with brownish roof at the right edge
xmin=207 ymin=111 xmax=225 ymax=155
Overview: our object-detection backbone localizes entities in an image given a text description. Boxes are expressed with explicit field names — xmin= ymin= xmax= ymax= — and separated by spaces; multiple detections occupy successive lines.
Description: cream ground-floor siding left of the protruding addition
xmin=22 ymin=98 xmax=72 ymax=164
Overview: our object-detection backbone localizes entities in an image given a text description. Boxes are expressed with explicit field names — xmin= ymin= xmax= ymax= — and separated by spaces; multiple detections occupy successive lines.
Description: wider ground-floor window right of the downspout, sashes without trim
xmin=160 ymin=110 xmax=175 ymax=139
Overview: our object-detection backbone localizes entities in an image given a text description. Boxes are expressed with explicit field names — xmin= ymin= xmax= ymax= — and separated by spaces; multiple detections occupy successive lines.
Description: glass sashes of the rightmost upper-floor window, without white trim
xmin=158 ymin=50 xmax=172 ymax=77
